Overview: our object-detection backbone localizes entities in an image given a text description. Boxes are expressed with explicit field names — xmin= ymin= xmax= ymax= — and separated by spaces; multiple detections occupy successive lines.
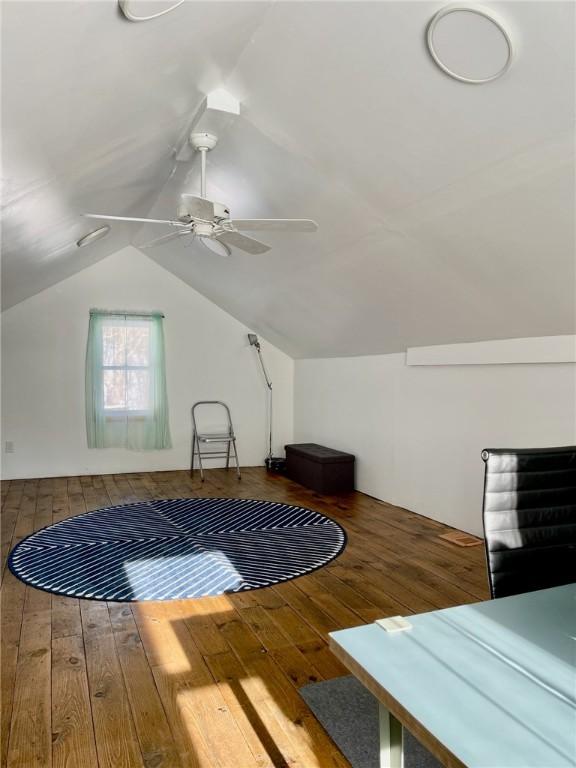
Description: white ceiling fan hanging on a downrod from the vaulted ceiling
xmin=83 ymin=133 xmax=318 ymax=256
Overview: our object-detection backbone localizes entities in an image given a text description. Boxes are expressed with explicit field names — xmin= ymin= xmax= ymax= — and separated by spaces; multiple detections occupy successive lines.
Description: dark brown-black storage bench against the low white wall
xmin=285 ymin=443 xmax=354 ymax=494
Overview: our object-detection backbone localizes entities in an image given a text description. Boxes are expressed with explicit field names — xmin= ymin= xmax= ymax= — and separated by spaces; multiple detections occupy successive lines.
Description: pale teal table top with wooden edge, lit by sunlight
xmin=330 ymin=585 xmax=576 ymax=768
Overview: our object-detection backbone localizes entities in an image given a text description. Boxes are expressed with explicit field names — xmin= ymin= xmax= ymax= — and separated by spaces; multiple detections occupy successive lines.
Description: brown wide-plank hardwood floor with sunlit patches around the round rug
xmin=1 ymin=468 xmax=488 ymax=768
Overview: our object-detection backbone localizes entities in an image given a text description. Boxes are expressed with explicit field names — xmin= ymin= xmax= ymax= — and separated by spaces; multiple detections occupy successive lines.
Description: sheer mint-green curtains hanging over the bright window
xmin=86 ymin=310 xmax=172 ymax=451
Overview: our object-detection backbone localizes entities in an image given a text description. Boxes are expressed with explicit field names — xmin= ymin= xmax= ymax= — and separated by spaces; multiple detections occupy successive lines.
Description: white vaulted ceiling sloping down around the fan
xmin=3 ymin=0 xmax=576 ymax=357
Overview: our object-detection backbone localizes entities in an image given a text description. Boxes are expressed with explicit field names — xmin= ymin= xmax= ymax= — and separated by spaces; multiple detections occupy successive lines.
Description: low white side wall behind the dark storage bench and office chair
xmin=294 ymin=354 xmax=576 ymax=534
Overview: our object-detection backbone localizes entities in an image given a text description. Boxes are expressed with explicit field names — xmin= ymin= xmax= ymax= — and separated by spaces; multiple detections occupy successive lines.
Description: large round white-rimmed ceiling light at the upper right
xmin=426 ymin=5 xmax=513 ymax=85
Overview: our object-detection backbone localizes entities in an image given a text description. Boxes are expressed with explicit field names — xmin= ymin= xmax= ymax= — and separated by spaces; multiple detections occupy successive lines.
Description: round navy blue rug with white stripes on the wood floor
xmin=8 ymin=499 xmax=346 ymax=602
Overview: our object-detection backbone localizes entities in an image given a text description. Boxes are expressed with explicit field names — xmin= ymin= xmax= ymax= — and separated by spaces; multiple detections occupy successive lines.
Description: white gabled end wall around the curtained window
xmin=2 ymin=247 xmax=293 ymax=478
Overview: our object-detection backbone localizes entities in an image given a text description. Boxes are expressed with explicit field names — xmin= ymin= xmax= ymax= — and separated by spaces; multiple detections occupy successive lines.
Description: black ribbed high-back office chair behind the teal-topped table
xmin=482 ymin=446 xmax=576 ymax=597
